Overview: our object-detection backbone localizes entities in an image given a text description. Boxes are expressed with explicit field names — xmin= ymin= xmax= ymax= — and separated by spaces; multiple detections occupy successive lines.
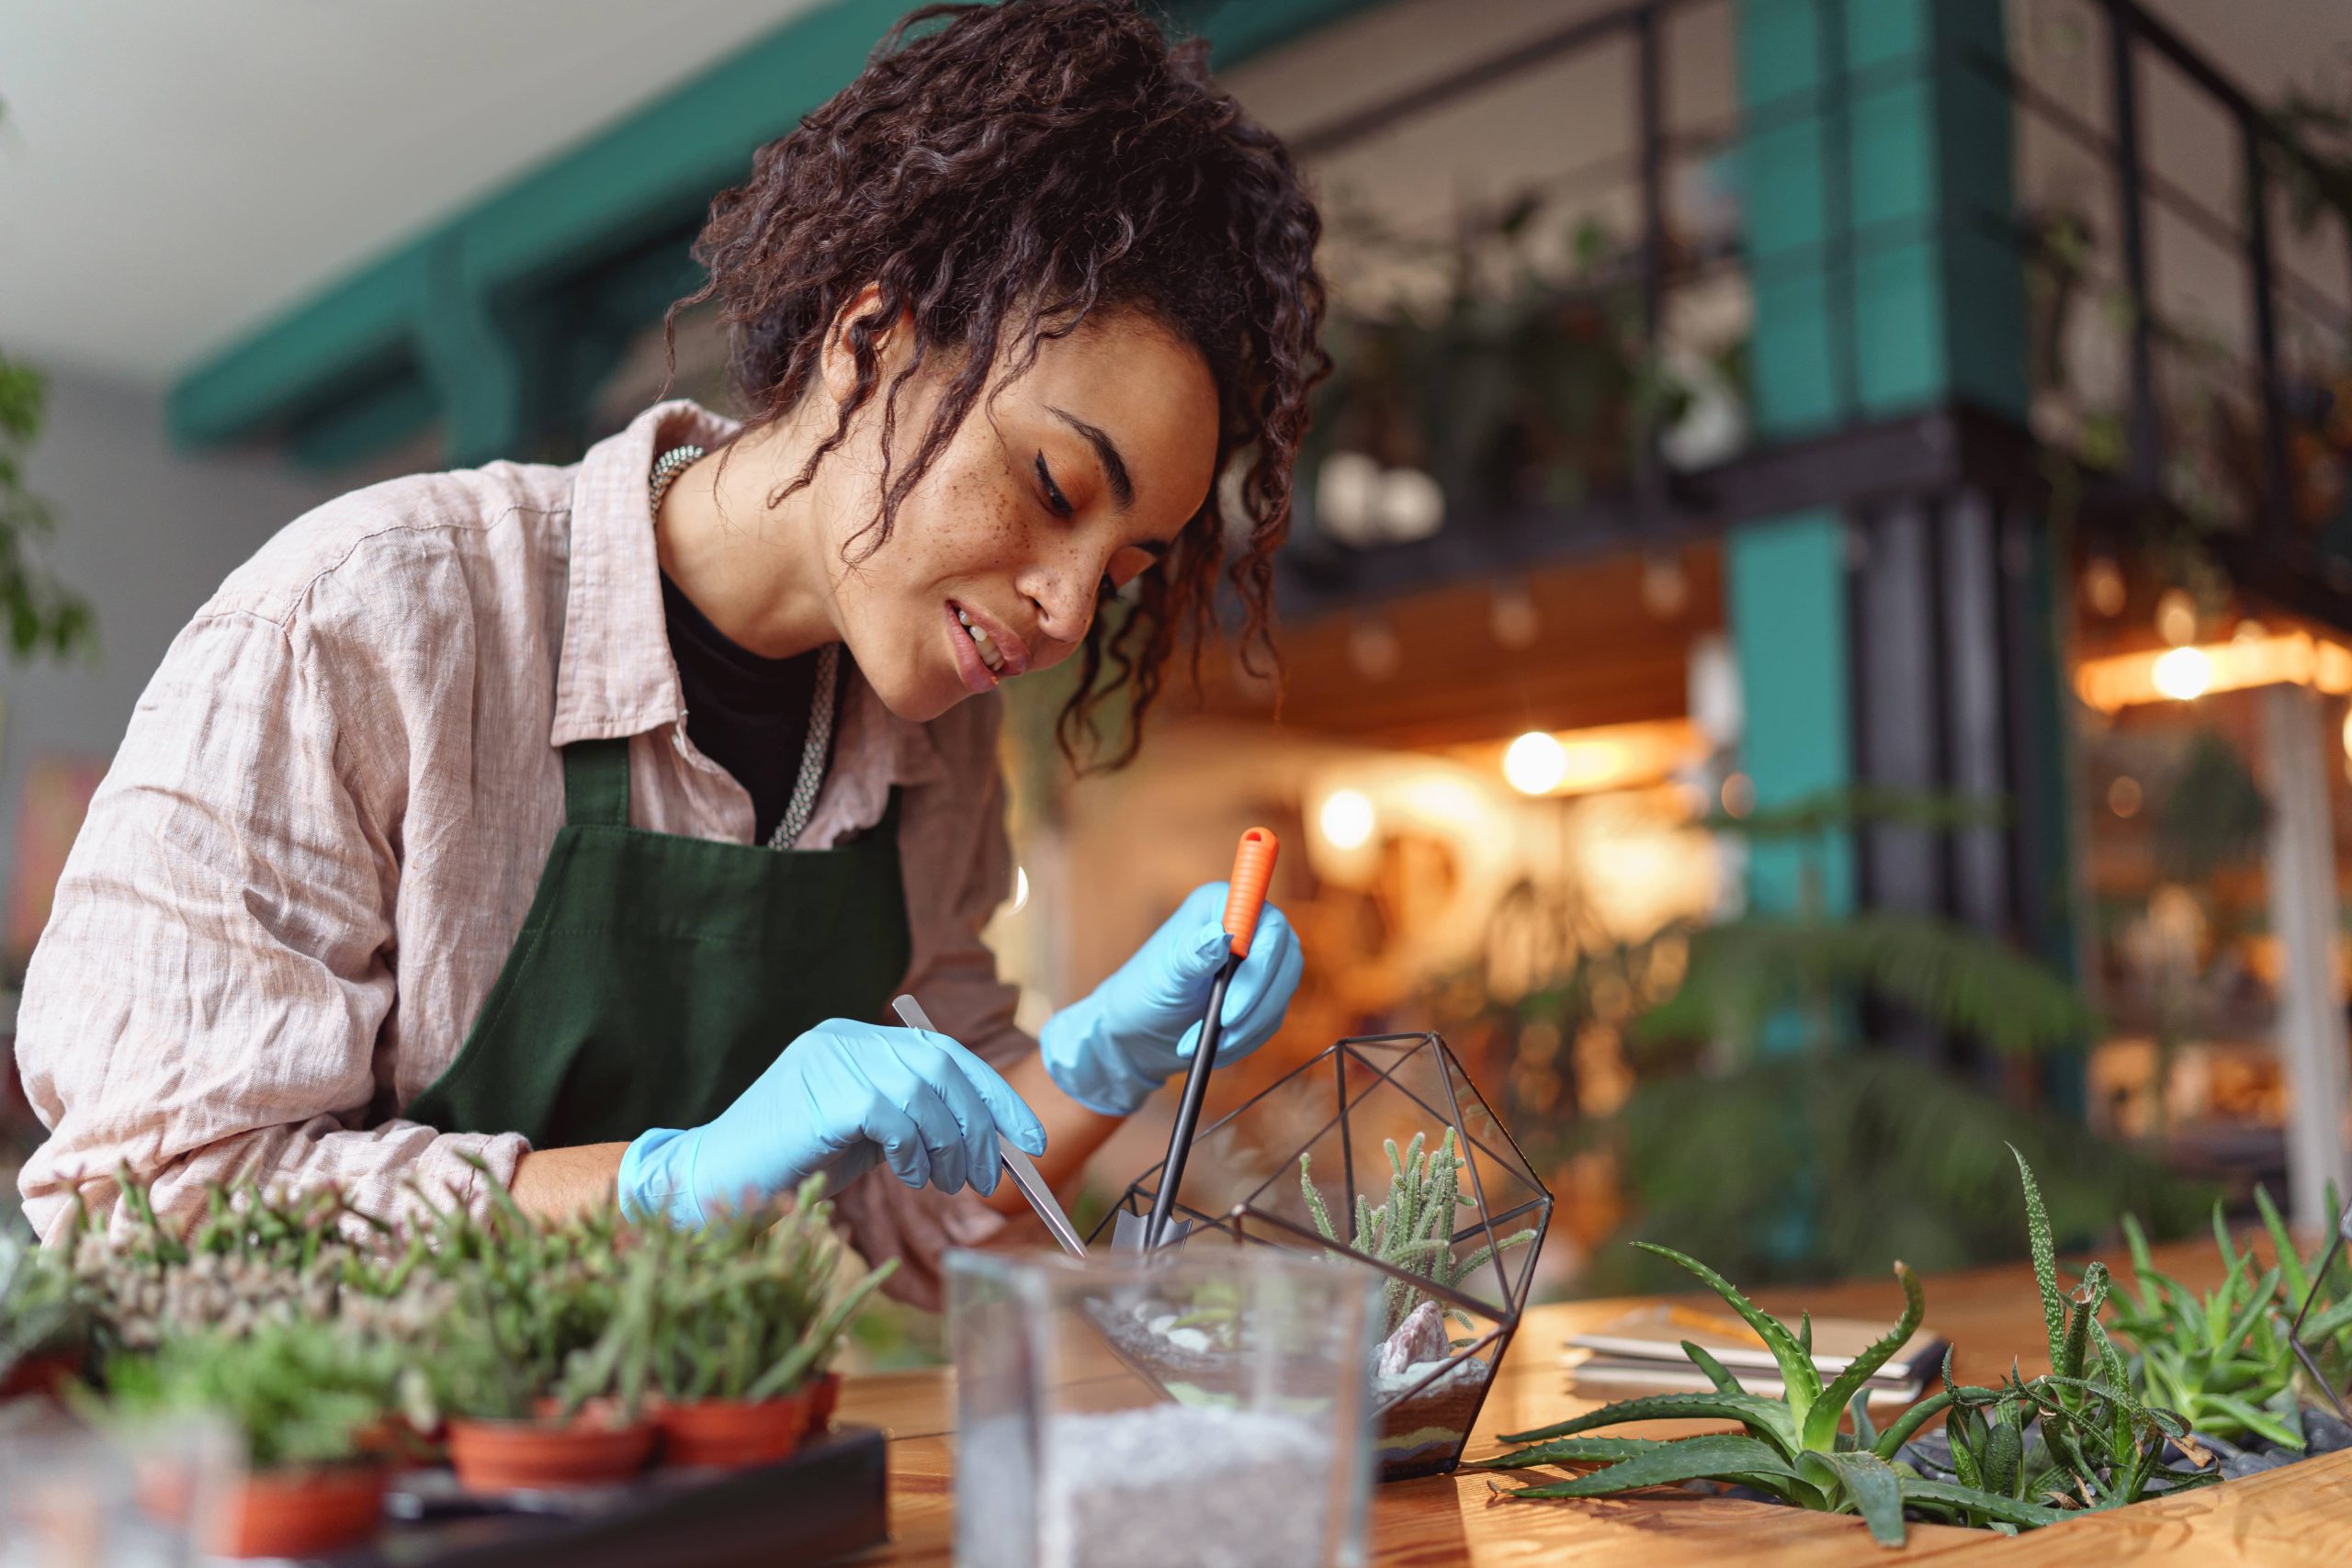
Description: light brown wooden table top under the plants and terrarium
xmin=842 ymin=1241 xmax=2352 ymax=1568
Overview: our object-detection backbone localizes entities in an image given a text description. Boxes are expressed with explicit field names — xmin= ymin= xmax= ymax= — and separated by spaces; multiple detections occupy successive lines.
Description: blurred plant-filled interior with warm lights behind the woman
xmin=0 ymin=0 xmax=2352 ymax=1335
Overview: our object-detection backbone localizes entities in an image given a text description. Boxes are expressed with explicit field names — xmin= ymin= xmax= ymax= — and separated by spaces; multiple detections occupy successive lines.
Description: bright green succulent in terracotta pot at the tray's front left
xmin=96 ymin=1321 xmax=400 ymax=1556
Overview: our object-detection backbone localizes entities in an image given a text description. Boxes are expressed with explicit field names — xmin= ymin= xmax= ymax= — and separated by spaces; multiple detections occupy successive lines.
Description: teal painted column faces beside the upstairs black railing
xmin=1726 ymin=0 xmax=2028 ymax=909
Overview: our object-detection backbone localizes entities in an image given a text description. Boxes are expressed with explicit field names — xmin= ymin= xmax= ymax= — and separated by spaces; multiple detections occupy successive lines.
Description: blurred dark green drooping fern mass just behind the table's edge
xmin=1583 ymin=1051 xmax=2213 ymax=1295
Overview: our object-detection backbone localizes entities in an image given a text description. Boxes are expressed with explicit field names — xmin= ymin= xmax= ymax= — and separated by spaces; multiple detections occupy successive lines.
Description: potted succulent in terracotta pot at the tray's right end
xmin=650 ymin=1178 xmax=896 ymax=1467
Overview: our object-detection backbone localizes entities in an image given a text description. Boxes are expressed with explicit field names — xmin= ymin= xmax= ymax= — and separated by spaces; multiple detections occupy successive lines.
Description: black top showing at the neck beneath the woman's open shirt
xmin=661 ymin=571 xmax=816 ymax=844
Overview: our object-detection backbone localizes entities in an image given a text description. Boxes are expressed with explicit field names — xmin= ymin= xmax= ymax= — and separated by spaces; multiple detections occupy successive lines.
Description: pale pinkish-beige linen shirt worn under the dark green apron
xmin=17 ymin=402 xmax=1033 ymax=1260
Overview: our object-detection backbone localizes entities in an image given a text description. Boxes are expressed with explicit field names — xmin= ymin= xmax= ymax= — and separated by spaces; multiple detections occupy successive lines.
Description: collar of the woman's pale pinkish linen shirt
xmin=548 ymin=400 xmax=945 ymax=808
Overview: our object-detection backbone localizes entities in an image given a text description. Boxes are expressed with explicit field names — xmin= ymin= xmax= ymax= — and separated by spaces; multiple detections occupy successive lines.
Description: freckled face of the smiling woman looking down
xmin=811 ymin=312 xmax=1218 ymax=722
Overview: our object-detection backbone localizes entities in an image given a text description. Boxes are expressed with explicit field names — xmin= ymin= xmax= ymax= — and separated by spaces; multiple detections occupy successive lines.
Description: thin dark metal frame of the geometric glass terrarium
xmin=1087 ymin=1030 xmax=1553 ymax=1481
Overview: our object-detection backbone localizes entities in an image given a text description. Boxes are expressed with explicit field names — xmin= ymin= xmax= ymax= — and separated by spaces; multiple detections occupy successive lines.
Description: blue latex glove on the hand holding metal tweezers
xmin=618 ymin=1018 xmax=1045 ymax=1224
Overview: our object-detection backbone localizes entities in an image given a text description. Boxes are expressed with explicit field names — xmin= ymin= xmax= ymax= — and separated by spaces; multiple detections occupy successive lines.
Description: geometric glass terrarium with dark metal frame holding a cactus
xmin=1089 ymin=1032 xmax=1553 ymax=1481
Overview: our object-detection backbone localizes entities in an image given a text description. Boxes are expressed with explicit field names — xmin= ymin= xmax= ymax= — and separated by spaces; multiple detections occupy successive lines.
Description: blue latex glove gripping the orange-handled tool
xmin=1037 ymin=882 xmax=1306 ymax=1117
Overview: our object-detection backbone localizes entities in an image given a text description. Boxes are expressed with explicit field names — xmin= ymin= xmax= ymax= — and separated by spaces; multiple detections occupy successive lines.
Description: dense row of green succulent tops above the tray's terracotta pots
xmin=74 ymin=1164 xmax=894 ymax=1460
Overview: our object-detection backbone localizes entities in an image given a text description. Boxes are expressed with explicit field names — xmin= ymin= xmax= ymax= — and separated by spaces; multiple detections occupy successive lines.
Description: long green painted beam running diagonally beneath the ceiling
xmin=169 ymin=0 xmax=1390 ymax=461
